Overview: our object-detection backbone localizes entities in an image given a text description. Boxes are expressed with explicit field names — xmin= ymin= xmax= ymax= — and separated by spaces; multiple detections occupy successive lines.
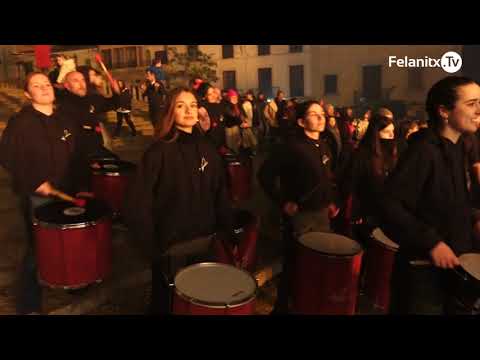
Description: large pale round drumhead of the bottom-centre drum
xmin=175 ymin=263 xmax=257 ymax=306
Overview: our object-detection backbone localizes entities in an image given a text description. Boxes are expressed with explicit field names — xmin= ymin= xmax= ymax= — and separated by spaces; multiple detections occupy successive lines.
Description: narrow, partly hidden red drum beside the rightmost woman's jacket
xmin=364 ymin=228 xmax=399 ymax=312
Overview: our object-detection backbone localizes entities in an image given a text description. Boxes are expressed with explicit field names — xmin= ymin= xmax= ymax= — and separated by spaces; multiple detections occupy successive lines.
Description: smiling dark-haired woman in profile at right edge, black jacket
xmin=382 ymin=76 xmax=480 ymax=314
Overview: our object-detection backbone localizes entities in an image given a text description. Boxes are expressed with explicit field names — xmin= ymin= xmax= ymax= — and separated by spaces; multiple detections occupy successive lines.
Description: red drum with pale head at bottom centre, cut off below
xmin=173 ymin=263 xmax=257 ymax=315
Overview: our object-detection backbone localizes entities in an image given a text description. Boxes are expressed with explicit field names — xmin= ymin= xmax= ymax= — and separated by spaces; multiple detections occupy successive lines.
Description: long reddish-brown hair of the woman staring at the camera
xmin=154 ymin=87 xmax=197 ymax=142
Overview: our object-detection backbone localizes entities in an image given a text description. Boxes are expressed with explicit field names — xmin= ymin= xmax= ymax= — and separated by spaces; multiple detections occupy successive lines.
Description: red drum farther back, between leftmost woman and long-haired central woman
xmin=91 ymin=159 xmax=136 ymax=216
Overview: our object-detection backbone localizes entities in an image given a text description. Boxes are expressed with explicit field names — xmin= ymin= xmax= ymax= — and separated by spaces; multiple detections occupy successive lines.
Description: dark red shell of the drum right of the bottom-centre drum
xmin=292 ymin=241 xmax=363 ymax=315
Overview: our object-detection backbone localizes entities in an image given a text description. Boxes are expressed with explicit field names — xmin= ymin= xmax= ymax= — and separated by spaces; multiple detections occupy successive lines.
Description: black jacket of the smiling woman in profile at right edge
xmin=383 ymin=129 xmax=480 ymax=258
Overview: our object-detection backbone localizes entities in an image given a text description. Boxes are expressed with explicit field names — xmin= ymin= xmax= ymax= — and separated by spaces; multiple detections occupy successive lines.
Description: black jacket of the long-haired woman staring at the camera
xmin=125 ymin=129 xmax=233 ymax=260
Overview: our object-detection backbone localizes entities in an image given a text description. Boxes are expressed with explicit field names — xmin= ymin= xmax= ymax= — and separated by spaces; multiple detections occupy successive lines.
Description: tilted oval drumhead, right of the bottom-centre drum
xmin=298 ymin=232 xmax=362 ymax=256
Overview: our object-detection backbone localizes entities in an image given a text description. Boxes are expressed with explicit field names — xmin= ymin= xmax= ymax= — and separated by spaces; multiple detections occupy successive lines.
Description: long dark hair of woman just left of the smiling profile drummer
xmin=360 ymin=114 xmax=398 ymax=179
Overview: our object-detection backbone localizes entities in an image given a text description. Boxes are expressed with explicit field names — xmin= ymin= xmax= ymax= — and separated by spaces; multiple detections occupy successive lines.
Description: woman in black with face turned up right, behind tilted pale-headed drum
xmin=257 ymin=101 xmax=339 ymax=313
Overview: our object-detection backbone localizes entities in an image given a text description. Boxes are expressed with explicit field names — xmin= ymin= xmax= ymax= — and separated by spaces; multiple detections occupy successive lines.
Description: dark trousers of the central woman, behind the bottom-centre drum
xmin=149 ymin=235 xmax=215 ymax=315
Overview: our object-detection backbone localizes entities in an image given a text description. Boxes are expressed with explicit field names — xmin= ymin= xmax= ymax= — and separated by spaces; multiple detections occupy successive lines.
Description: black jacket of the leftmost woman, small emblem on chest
xmin=0 ymin=105 xmax=88 ymax=196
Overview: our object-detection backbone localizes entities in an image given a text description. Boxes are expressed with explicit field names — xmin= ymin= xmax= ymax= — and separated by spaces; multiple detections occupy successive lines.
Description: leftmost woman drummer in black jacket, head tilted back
xmin=0 ymin=72 xmax=93 ymax=314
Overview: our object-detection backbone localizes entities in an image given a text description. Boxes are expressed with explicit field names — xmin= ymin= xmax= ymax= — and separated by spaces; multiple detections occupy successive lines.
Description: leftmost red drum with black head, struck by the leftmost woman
xmin=34 ymin=199 xmax=112 ymax=289
